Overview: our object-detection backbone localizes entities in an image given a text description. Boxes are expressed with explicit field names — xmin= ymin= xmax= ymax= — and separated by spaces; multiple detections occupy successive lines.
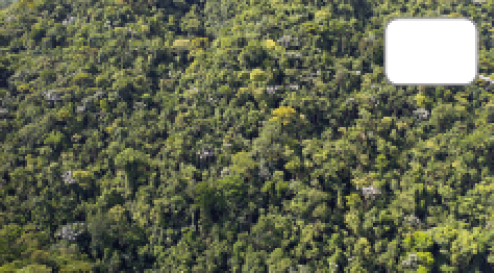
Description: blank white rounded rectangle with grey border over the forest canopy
xmin=384 ymin=17 xmax=478 ymax=85
